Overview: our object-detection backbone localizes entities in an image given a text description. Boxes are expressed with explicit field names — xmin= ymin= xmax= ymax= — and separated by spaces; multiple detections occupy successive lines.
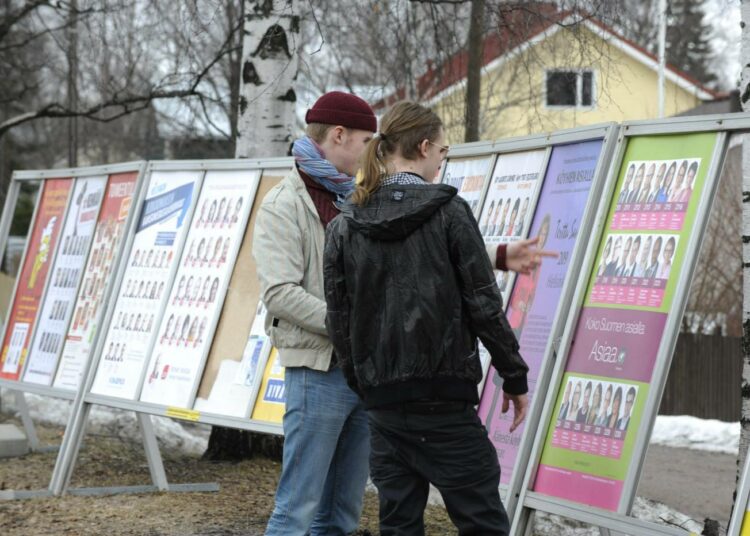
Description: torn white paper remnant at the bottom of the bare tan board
xmin=193 ymin=302 xmax=272 ymax=417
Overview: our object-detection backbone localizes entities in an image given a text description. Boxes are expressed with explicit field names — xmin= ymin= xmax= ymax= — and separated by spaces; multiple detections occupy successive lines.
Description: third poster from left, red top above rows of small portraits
xmin=53 ymin=172 xmax=138 ymax=391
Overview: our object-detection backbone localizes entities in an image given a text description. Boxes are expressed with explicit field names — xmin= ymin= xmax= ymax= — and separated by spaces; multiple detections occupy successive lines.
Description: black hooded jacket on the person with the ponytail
xmin=324 ymin=184 xmax=528 ymax=408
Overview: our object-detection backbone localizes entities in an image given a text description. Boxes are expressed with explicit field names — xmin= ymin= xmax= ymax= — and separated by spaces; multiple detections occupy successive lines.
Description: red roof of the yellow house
xmin=373 ymin=2 xmax=719 ymax=110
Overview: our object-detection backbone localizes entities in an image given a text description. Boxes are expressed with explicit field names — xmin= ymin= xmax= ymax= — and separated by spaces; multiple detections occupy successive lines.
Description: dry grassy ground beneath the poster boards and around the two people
xmin=0 ymin=414 xmax=453 ymax=536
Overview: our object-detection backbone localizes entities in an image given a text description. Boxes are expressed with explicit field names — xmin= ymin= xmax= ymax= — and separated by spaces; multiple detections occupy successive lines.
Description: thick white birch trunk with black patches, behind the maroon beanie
xmin=235 ymin=0 xmax=300 ymax=158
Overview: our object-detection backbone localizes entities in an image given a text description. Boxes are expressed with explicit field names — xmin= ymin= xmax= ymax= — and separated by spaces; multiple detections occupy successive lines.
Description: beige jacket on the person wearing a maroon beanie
xmin=253 ymin=167 xmax=333 ymax=370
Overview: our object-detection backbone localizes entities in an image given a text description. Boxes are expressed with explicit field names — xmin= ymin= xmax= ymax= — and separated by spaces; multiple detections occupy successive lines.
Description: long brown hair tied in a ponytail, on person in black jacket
xmin=352 ymin=101 xmax=443 ymax=205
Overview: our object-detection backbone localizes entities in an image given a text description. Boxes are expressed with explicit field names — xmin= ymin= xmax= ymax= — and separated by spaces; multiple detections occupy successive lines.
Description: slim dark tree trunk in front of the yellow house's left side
xmin=464 ymin=0 xmax=485 ymax=142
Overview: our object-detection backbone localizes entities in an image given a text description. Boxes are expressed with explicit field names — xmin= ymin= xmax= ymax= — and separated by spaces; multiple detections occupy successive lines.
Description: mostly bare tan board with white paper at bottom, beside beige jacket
xmin=193 ymin=169 xmax=290 ymax=418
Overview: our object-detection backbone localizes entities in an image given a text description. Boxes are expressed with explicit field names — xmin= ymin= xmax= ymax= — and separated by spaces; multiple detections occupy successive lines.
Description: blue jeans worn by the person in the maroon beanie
xmin=266 ymin=367 xmax=370 ymax=536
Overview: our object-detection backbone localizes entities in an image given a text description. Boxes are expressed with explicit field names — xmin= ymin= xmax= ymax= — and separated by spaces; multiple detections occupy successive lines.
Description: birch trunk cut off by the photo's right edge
xmin=737 ymin=0 xmax=750 ymax=486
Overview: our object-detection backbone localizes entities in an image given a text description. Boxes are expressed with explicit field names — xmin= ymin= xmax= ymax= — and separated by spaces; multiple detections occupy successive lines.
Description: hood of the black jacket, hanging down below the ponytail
xmin=342 ymin=184 xmax=458 ymax=240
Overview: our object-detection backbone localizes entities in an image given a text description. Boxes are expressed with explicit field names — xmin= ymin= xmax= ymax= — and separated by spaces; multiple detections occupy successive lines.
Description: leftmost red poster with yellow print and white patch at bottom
xmin=0 ymin=179 xmax=73 ymax=381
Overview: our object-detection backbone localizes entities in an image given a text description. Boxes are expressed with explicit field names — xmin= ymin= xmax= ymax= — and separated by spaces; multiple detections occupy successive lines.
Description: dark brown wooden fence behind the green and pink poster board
xmin=659 ymin=333 xmax=742 ymax=422
